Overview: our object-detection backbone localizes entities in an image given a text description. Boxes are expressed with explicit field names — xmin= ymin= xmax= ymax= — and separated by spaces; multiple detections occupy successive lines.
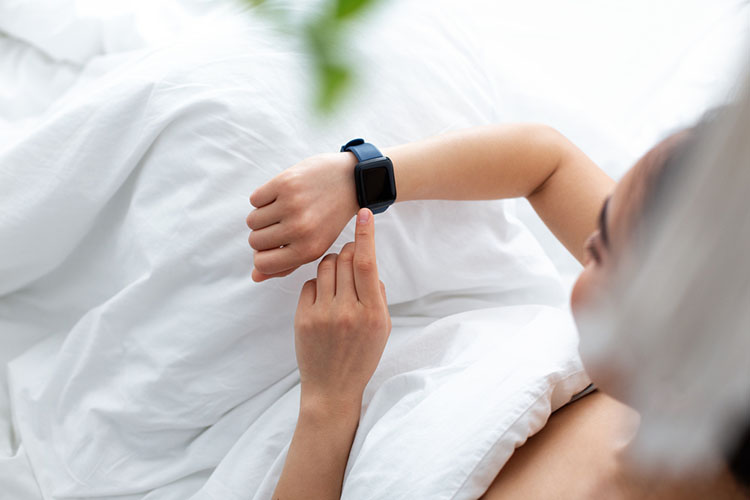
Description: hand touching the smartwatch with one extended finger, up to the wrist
xmin=294 ymin=209 xmax=391 ymax=417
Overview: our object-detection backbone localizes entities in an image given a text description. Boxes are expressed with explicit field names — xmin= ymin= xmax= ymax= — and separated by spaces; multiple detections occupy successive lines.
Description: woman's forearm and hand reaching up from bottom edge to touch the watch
xmin=273 ymin=209 xmax=391 ymax=500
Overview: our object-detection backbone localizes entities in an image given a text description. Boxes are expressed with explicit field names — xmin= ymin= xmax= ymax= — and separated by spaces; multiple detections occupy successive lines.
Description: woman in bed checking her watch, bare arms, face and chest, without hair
xmin=247 ymin=119 xmax=750 ymax=499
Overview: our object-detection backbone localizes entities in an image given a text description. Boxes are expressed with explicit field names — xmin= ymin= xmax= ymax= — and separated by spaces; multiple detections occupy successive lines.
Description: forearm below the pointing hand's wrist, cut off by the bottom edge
xmin=273 ymin=403 xmax=359 ymax=500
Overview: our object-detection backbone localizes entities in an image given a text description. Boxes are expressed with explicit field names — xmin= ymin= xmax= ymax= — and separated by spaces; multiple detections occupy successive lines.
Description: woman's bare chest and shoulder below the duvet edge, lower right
xmin=482 ymin=392 xmax=747 ymax=500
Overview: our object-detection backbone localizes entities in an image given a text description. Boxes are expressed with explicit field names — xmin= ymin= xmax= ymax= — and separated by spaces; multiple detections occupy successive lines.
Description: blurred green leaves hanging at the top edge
xmin=244 ymin=0 xmax=383 ymax=114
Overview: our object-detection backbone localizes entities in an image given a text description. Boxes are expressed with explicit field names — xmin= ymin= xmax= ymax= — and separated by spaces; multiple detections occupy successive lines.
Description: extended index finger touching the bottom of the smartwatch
xmin=352 ymin=208 xmax=382 ymax=305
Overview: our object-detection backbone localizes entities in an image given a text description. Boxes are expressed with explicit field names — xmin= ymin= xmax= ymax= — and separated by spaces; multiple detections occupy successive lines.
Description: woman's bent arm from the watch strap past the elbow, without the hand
xmin=385 ymin=124 xmax=614 ymax=260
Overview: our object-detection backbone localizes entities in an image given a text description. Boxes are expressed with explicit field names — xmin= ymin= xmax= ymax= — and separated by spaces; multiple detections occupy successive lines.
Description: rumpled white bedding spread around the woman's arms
xmin=0 ymin=1 xmax=747 ymax=500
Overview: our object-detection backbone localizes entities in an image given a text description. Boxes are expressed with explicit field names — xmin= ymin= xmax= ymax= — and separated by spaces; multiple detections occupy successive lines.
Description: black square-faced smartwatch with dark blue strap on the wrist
xmin=341 ymin=139 xmax=396 ymax=214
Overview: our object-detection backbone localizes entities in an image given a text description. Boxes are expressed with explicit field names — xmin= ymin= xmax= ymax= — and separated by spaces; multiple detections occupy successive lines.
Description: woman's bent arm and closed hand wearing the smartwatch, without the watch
xmin=247 ymin=124 xmax=614 ymax=281
